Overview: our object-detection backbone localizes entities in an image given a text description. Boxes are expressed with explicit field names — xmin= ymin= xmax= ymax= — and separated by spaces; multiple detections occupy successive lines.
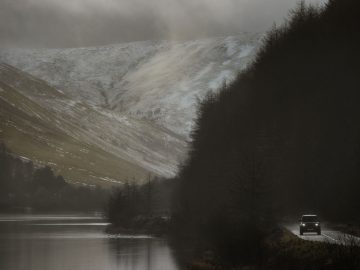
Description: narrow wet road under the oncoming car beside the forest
xmin=283 ymin=223 xmax=360 ymax=246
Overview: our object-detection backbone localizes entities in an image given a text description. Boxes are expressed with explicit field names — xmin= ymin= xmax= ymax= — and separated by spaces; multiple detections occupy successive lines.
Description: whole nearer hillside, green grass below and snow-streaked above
xmin=0 ymin=64 xmax=186 ymax=186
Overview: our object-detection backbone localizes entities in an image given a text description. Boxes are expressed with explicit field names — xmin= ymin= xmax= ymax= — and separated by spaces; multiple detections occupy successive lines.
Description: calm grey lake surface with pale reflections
xmin=0 ymin=215 xmax=181 ymax=270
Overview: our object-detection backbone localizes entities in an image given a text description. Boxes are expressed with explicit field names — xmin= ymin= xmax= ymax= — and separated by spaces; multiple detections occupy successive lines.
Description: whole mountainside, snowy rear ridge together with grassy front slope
xmin=0 ymin=33 xmax=261 ymax=182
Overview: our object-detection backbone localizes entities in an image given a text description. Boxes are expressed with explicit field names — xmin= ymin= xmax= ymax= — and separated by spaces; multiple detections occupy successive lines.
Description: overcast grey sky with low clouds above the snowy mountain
xmin=0 ymin=0 xmax=324 ymax=47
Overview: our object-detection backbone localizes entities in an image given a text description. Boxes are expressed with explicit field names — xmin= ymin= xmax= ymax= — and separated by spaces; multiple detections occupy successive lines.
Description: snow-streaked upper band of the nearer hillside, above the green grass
xmin=0 ymin=63 xmax=187 ymax=178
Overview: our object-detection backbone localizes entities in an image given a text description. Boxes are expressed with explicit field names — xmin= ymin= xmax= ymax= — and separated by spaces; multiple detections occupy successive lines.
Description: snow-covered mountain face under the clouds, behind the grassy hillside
xmin=0 ymin=33 xmax=261 ymax=137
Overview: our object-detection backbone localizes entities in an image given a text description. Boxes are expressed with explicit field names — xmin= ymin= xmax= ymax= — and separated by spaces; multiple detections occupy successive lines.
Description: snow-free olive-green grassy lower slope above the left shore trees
xmin=0 ymin=81 xmax=147 ymax=186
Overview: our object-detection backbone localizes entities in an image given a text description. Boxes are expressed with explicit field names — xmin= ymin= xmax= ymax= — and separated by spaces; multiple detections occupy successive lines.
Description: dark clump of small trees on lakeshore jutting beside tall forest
xmin=106 ymin=177 xmax=174 ymax=234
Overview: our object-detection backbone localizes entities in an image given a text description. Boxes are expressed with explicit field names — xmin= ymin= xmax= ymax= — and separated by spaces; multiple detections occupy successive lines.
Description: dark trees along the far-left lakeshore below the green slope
xmin=0 ymin=144 xmax=107 ymax=211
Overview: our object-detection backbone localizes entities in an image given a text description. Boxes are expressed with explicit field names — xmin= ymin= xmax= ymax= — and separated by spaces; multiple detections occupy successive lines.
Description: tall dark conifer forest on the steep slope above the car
xmin=173 ymin=0 xmax=360 ymax=261
